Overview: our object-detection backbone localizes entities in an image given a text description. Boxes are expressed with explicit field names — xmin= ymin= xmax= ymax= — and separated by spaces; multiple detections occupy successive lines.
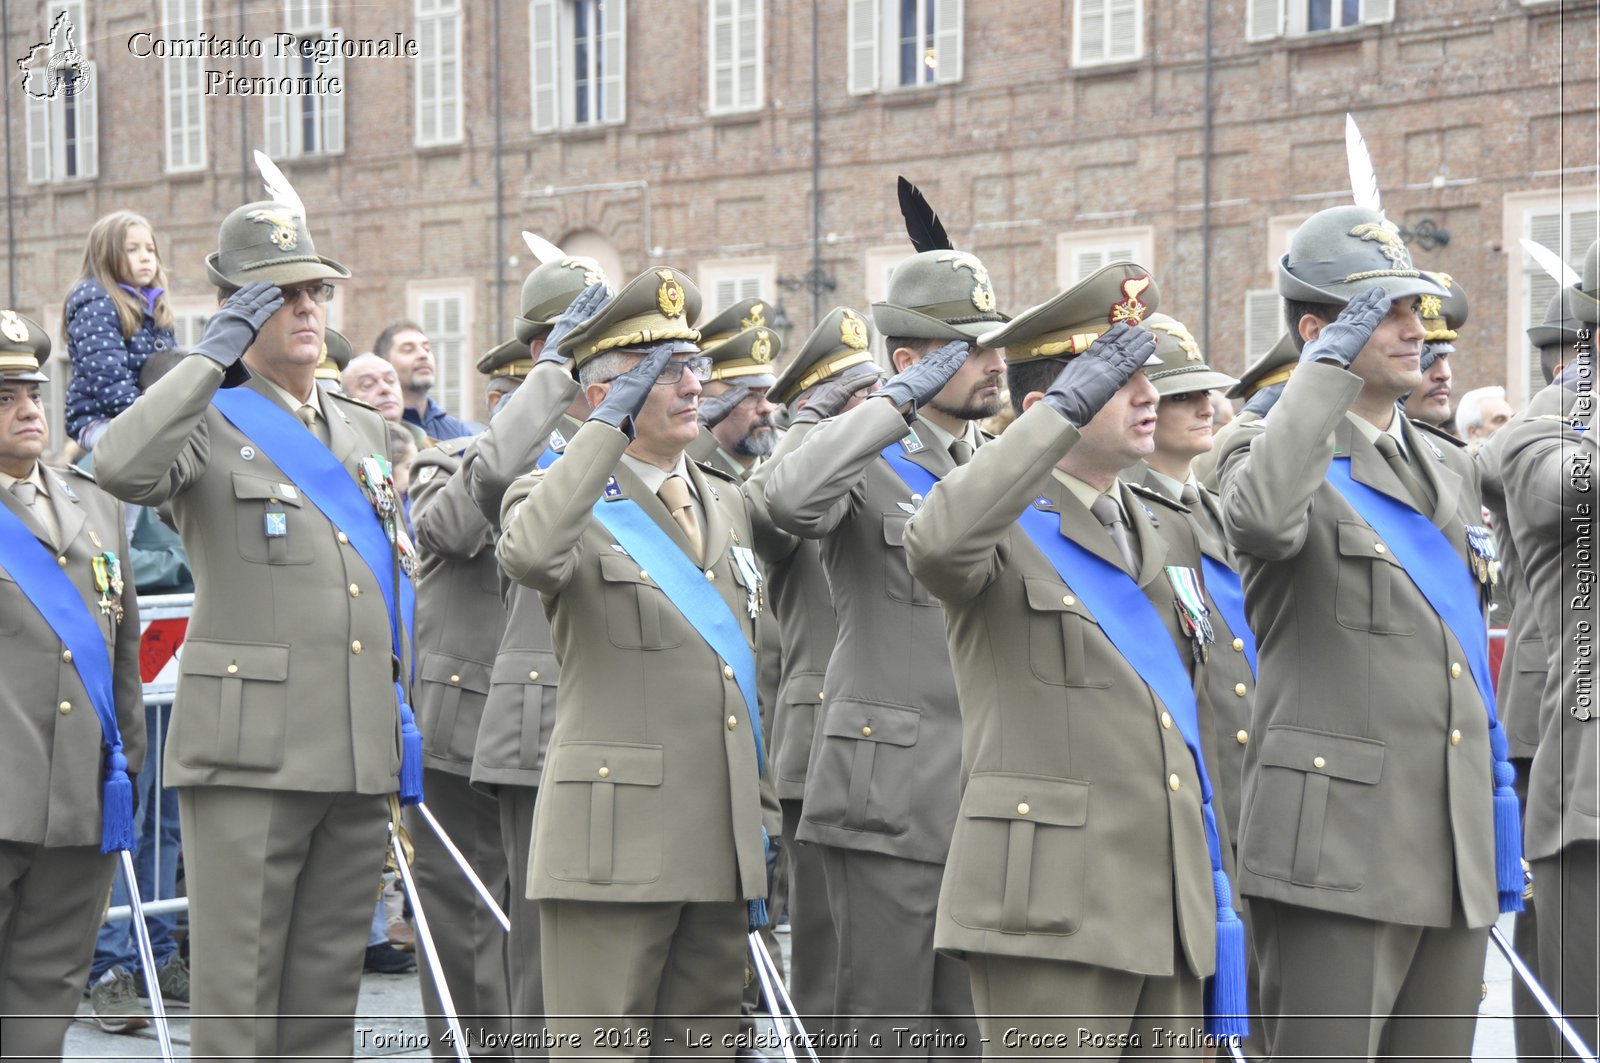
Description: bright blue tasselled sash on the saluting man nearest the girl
xmin=211 ymin=387 xmax=422 ymax=805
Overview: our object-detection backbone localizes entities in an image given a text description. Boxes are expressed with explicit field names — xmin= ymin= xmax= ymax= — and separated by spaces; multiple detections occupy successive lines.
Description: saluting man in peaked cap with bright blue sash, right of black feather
xmin=906 ymin=263 xmax=1245 ymax=1057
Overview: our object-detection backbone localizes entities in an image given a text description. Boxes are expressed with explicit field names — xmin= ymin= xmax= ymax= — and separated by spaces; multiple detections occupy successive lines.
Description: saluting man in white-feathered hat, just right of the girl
xmin=96 ymin=202 xmax=421 ymax=1058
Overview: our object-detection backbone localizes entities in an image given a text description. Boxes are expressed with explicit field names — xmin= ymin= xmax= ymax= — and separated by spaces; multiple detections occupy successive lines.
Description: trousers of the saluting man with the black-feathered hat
xmin=818 ymin=845 xmax=979 ymax=1060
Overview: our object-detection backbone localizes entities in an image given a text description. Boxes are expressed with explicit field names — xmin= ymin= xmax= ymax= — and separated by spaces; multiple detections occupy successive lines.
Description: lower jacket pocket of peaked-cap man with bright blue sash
xmin=946 ymin=772 xmax=1090 ymax=935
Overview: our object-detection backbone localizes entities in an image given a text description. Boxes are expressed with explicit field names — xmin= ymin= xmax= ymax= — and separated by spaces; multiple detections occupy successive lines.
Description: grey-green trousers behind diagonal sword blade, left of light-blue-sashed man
xmin=405 ymin=768 xmax=510 ymax=1060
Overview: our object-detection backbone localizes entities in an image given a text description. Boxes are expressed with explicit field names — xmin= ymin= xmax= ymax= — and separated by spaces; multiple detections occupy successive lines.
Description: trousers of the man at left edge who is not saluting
xmin=0 ymin=840 xmax=117 ymax=1058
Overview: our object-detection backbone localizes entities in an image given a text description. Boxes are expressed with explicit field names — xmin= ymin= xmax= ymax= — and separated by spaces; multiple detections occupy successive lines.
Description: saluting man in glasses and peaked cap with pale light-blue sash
xmin=496 ymin=267 xmax=778 ymax=1057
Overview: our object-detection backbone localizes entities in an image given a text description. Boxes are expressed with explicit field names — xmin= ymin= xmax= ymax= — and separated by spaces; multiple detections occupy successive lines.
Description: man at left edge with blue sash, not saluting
xmin=0 ymin=309 xmax=146 ymax=1060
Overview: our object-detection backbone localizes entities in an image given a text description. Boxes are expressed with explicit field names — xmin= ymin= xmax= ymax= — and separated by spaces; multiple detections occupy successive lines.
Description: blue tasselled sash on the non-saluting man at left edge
xmin=0 ymin=506 xmax=134 ymax=853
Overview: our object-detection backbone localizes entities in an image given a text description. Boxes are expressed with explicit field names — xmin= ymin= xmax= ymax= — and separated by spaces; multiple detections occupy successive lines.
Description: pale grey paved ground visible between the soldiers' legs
xmin=64 ymin=916 xmax=1517 ymax=1063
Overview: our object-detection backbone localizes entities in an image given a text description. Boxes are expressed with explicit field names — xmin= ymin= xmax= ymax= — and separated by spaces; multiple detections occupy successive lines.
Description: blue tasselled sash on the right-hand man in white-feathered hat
xmin=1328 ymin=458 xmax=1523 ymax=913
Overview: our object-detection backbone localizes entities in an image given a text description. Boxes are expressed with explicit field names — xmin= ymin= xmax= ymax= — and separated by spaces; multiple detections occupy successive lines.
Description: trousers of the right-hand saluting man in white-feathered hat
xmin=1246 ymin=897 xmax=1490 ymax=1060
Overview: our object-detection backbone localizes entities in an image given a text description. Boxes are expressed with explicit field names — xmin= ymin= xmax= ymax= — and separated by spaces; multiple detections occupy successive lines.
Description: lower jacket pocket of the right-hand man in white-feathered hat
xmin=1245 ymin=725 xmax=1386 ymax=890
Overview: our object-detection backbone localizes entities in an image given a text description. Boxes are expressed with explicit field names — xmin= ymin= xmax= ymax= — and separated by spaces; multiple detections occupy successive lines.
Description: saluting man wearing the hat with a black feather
xmin=765 ymin=251 xmax=1006 ymax=1058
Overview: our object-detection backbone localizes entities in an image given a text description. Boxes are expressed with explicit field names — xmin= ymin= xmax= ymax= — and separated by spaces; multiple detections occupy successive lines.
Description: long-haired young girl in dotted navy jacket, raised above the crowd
xmin=64 ymin=210 xmax=173 ymax=450
